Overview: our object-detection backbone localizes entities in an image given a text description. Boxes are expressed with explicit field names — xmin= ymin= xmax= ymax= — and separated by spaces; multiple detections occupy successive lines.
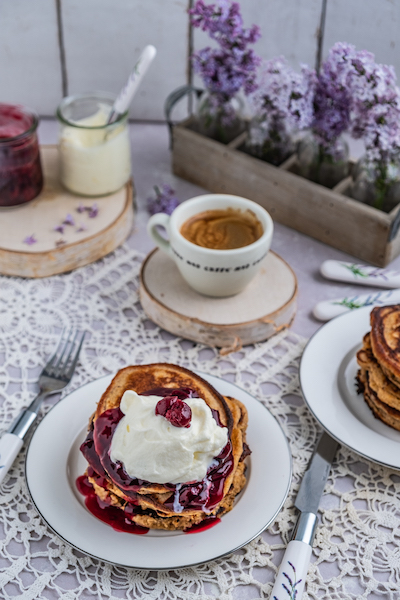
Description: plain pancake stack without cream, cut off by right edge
xmin=357 ymin=304 xmax=400 ymax=431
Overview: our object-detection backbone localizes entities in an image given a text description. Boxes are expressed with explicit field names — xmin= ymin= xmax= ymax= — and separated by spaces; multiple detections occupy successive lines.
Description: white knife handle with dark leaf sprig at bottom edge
xmin=270 ymin=540 xmax=312 ymax=600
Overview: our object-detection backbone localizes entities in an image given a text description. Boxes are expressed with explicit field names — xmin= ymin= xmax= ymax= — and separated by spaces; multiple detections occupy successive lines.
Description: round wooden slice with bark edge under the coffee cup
xmin=140 ymin=248 xmax=297 ymax=354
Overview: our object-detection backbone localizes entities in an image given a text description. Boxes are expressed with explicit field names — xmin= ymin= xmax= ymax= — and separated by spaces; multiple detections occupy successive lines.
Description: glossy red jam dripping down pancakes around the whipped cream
xmin=77 ymin=388 xmax=234 ymax=533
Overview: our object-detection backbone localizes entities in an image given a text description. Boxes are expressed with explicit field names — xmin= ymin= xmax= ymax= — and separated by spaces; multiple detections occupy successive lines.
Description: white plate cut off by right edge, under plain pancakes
xmin=300 ymin=306 xmax=400 ymax=469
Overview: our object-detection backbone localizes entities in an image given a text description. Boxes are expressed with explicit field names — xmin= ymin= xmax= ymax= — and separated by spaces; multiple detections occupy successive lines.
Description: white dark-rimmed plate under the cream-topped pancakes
xmin=26 ymin=373 xmax=292 ymax=570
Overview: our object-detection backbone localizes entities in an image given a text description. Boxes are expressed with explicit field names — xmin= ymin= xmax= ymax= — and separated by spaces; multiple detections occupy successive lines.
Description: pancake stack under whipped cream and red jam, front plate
xmin=81 ymin=363 xmax=250 ymax=530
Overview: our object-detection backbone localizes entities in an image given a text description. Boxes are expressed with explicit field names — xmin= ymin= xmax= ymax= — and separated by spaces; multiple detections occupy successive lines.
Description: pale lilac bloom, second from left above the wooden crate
xmin=253 ymin=56 xmax=316 ymax=129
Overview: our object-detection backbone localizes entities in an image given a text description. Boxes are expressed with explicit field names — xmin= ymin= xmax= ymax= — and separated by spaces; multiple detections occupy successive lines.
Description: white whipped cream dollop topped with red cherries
xmin=110 ymin=390 xmax=228 ymax=484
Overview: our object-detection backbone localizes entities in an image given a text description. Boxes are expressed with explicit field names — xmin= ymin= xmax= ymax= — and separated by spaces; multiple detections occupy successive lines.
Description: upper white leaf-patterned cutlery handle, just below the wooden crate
xmin=320 ymin=260 xmax=400 ymax=289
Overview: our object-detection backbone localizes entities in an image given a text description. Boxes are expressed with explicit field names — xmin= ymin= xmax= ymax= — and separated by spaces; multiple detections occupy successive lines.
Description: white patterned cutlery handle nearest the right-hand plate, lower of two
xmin=313 ymin=290 xmax=400 ymax=321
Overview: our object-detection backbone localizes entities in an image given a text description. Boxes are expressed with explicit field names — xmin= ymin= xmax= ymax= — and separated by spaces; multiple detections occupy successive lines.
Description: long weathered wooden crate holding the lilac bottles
xmin=172 ymin=119 xmax=400 ymax=267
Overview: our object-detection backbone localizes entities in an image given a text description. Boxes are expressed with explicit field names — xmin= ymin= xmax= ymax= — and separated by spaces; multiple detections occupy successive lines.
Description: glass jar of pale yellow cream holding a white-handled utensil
xmin=57 ymin=92 xmax=131 ymax=196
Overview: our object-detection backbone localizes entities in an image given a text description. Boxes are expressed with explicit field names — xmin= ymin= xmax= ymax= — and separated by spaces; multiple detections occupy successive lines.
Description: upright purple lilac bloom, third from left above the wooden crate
xmin=312 ymin=42 xmax=356 ymax=156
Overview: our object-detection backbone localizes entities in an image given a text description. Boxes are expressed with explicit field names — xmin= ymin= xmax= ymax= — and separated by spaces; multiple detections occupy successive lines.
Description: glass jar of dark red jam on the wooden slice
xmin=0 ymin=103 xmax=43 ymax=208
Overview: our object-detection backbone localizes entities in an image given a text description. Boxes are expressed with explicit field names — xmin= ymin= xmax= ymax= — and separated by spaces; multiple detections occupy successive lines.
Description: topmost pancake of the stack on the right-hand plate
xmin=371 ymin=304 xmax=400 ymax=387
